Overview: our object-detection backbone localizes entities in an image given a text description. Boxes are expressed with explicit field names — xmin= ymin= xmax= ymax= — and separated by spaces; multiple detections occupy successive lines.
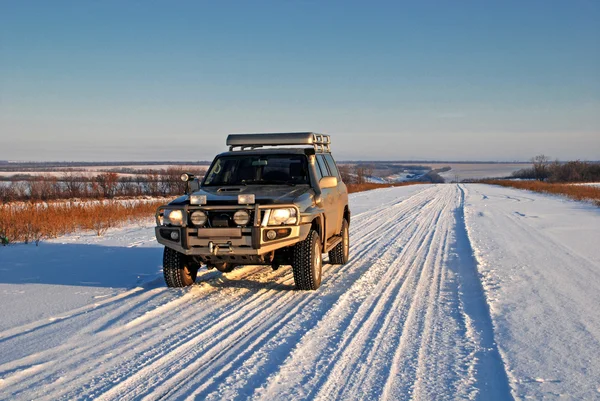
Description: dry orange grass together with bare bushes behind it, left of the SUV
xmin=0 ymin=167 xmax=204 ymax=245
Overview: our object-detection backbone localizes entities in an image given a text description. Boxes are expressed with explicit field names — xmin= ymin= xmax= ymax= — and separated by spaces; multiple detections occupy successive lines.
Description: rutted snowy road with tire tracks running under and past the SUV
xmin=0 ymin=185 xmax=516 ymax=400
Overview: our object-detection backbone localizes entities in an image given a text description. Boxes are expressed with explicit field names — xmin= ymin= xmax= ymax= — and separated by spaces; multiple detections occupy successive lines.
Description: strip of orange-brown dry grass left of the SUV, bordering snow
xmin=0 ymin=200 xmax=166 ymax=244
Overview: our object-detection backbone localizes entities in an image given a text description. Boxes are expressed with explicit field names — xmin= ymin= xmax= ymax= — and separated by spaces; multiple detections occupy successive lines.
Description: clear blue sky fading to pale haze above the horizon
xmin=0 ymin=0 xmax=600 ymax=161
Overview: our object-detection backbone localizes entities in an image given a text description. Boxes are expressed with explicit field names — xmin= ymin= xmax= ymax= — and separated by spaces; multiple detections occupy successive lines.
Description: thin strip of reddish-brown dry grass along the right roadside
xmin=483 ymin=180 xmax=600 ymax=206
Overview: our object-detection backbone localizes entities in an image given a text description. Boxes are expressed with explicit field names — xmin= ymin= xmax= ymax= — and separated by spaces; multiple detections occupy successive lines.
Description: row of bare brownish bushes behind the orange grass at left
xmin=0 ymin=167 xmax=205 ymax=203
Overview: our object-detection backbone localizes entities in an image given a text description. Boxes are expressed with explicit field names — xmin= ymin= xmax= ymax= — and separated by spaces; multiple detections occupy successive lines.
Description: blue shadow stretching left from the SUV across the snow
xmin=0 ymin=242 xmax=162 ymax=288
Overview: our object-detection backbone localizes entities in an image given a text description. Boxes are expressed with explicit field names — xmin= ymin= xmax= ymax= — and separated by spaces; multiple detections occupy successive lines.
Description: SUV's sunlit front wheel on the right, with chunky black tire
xmin=292 ymin=230 xmax=323 ymax=290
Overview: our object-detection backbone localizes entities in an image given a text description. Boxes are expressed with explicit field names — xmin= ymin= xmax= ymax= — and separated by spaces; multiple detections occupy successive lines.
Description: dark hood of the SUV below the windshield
xmin=171 ymin=185 xmax=311 ymax=206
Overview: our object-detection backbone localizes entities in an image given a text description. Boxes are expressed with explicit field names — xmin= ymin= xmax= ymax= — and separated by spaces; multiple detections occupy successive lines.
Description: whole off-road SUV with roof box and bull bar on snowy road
xmin=156 ymin=132 xmax=350 ymax=290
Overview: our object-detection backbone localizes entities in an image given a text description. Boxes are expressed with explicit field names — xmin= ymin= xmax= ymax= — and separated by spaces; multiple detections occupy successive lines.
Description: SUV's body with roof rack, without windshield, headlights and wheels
xmin=156 ymin=133 xmax=350 ymax=264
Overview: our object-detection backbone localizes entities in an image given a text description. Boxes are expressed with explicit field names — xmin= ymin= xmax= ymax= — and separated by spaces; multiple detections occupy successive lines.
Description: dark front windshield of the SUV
xmin=204 ymin=155 xmax=308 ymax=186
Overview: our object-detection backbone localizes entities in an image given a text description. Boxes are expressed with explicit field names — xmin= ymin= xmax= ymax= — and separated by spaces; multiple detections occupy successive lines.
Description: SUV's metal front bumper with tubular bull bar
xmin=155 ymin=205 xmax=311 ymax=256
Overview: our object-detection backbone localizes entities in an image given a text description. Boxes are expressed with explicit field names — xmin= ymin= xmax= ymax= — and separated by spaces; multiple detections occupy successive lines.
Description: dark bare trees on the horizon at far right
xmin=512 ymin=155 xmax=600 ymax=182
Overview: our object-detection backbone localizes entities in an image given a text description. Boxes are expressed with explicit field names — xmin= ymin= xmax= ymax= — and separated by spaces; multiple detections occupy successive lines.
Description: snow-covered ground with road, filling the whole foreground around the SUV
xmin=0 ymin=184 xmax=600 ymax=400
